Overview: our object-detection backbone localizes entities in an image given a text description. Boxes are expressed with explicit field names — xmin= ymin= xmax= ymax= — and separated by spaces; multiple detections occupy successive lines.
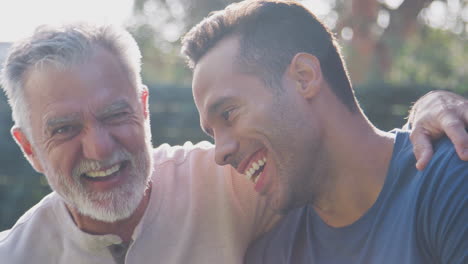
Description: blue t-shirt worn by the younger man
xmin=245 ymin=131 xmax=468 ymax=264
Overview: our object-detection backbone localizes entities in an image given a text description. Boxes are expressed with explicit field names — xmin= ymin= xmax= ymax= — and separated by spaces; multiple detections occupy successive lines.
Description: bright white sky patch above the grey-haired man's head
xmin=0 ymin=0 xmax=133 ymax=42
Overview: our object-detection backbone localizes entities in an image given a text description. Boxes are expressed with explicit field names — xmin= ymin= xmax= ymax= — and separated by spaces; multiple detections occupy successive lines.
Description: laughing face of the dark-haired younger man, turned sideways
xmin=192 ymin=37 xmax=326 ymax=212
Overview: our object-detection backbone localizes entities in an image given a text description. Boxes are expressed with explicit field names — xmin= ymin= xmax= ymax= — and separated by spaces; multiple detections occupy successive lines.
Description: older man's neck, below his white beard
xmin=67 ymin=186 xmax=151 ymax=242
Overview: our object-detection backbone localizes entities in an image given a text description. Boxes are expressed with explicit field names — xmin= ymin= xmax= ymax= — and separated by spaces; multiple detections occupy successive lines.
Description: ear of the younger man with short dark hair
xmin=289 ymin=52 xmax=323 ymax=99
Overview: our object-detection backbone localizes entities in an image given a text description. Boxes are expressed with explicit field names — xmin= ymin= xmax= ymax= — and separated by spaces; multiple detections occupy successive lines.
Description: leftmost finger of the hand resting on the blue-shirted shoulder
xmin=410 ymin=129 xmax=433 ymax=170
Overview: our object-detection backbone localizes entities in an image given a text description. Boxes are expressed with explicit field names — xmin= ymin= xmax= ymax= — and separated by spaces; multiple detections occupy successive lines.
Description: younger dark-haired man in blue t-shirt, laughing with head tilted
xmin=183 ymin=0 xmax=468 ymax=264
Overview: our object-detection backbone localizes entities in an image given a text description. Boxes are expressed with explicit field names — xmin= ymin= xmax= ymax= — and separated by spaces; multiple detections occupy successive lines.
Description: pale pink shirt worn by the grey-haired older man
xmin=0 ymin=142 xmax=274 ymax=264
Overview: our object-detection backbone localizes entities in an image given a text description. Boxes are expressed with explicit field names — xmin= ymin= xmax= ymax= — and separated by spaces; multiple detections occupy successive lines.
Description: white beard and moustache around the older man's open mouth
xmin=41 ymin=143 xmax=152 ymax=222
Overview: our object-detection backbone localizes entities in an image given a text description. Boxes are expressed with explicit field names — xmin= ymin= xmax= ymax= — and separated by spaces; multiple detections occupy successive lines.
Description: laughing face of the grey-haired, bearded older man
xmin=25 ymin=48 xmax=151 ymax=222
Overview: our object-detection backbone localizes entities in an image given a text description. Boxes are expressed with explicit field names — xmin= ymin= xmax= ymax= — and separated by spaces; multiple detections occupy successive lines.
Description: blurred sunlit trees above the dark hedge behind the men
xmin=131 ymin=0 xmax=468 ymax=88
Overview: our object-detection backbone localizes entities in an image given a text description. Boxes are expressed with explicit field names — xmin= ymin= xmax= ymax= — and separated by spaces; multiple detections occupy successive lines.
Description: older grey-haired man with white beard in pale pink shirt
xmin=0 ymin=25 xmax=466 ymax=264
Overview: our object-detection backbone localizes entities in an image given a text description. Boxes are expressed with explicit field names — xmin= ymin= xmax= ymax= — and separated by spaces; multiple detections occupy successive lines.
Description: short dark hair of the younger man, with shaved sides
xmin=182 ymin=0 xmax=357 ymax=112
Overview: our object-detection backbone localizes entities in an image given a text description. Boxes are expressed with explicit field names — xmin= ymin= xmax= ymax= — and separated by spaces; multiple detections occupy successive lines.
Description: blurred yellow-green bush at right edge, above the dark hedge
xmin=389 ymin=28 xmax=468 ymax=93
